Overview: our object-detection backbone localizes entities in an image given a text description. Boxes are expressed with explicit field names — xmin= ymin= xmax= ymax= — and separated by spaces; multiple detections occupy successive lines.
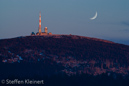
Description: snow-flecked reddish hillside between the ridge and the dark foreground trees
xmin=0 ymin=35 xmax=129 ymax=77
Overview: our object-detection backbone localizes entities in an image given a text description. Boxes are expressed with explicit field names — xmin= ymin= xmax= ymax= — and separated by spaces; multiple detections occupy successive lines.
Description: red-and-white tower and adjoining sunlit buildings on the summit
xmin=31 ymin=12 xmax=52 ymax=36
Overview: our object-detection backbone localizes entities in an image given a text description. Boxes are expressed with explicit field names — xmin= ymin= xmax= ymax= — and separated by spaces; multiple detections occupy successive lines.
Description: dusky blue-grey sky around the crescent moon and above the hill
xmin=0 ymin=0 xmax=129 ymax=45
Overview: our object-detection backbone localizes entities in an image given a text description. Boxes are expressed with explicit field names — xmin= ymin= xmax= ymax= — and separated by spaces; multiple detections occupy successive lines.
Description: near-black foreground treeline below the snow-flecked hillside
xmin=0 ymin=63 xmax=129 ymax=86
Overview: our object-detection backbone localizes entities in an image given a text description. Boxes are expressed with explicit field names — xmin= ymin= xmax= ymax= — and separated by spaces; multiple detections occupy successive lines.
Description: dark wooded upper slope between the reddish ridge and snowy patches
xmin=0 ymin=36 xmax=129 ymax=66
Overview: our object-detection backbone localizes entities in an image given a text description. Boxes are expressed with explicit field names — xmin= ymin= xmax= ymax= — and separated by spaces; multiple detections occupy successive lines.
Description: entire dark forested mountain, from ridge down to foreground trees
xmin=0 ymin=35 xmax=129 ymax=86
